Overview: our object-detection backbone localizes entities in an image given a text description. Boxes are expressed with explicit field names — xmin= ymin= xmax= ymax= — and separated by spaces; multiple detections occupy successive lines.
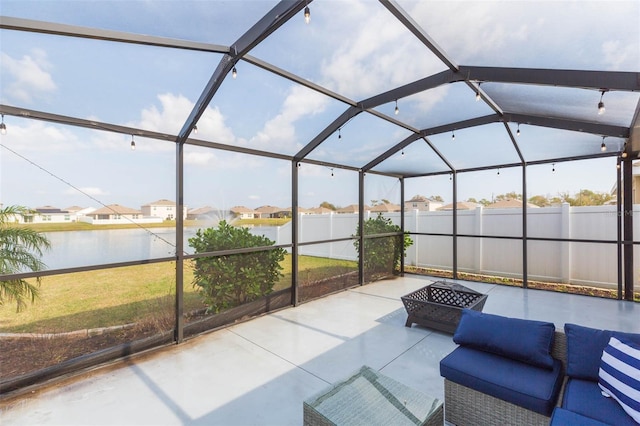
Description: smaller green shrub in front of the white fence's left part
xmin=353 ymin=213 xmax=413 ymax=274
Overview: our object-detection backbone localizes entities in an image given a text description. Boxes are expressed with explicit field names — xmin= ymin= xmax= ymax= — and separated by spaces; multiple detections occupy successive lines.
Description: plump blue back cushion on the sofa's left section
xmin=453 ymin=309 xmax=556 ymax=374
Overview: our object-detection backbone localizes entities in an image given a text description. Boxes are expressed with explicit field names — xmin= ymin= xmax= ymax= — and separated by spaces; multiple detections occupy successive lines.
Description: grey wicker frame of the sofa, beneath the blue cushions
xmin=444 ymin=331 xmax=567 ymax=426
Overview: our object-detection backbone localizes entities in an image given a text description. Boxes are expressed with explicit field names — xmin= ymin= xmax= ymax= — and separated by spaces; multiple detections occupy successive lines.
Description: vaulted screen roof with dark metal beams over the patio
xmin=0 ymin=0 xmax=640 ymax=177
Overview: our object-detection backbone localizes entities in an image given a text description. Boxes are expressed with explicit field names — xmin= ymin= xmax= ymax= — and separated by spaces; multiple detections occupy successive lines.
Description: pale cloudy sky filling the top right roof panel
xmin=409 ymin=1 xmax=639 ymax=69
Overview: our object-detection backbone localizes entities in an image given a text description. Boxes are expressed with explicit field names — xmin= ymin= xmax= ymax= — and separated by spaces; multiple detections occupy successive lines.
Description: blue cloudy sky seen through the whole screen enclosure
xmin=0 ymin=0 xmax=640 ymax=209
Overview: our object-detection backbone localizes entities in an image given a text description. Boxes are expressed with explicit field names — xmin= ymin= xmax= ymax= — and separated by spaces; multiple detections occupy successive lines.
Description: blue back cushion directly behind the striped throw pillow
xmin=564 ymin=323 xmax=640 ymax=382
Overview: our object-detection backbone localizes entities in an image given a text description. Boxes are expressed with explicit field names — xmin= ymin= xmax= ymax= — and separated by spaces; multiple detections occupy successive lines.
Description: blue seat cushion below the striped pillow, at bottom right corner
xmin=562 ymin=379 xmax=638 ymax=426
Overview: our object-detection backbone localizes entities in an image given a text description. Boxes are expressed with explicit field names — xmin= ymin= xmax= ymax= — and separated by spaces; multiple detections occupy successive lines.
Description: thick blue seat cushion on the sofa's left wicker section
xmin=440 ymin=346 xmax=564 ymax=416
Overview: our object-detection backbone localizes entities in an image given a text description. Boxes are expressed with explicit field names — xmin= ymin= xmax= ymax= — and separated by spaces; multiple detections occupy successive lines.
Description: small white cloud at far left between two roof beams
xmin=0 ymin=49 xmax=57 ymax=103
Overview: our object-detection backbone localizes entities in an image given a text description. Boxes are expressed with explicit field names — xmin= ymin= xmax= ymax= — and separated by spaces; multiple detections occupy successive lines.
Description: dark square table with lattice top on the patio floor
xmin=401 ymin=281 xmax=487 ymax=334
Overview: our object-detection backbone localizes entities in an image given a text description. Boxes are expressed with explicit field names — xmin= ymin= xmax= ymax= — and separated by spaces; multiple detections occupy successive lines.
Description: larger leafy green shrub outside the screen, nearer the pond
xmin=189 ymin=220 xmax=286 ymax=312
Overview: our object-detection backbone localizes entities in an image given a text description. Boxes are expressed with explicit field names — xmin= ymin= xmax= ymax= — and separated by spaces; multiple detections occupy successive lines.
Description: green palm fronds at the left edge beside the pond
xmin=0 ymin=206 xmax=51 ymax=312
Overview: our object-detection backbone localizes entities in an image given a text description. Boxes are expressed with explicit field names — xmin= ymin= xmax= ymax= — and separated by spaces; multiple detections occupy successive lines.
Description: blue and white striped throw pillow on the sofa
xmin=598 ymin=337 xmax=640 ymax=423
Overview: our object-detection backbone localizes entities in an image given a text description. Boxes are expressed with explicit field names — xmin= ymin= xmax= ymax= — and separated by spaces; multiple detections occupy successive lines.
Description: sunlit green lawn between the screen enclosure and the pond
xmin=0 ymin=255 xmax=357 ymax=333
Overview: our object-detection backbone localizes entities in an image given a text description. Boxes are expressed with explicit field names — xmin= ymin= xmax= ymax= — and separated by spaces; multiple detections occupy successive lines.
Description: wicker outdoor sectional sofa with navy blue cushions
xmin=440 ymin=309 xmax=640 ymax=426
